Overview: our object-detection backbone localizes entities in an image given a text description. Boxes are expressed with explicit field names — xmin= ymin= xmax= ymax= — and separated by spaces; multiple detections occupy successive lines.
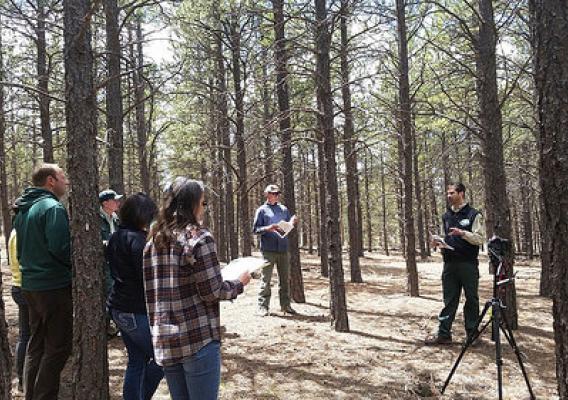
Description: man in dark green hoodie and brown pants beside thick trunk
xmin=14 ymin=164 xmax=73 ymax=400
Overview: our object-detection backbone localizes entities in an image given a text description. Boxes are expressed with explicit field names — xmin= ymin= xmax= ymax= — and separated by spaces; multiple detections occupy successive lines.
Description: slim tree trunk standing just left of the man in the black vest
xmin=396 ymin=0 xmax=419 ymax=296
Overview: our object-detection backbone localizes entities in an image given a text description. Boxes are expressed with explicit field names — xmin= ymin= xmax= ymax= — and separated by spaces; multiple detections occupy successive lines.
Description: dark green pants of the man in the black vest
xmin=438 ymin=261 xmax=479 ymax=337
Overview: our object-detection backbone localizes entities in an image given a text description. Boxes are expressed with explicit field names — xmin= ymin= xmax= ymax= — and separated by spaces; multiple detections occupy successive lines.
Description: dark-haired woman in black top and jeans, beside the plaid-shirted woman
xmin=106 ymin=193 xmax=164 ymax=400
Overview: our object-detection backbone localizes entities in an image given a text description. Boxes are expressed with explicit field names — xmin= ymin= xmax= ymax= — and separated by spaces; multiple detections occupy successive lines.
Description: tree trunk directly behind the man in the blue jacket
xmin=272 ymin=0 xmax=306 ymax=303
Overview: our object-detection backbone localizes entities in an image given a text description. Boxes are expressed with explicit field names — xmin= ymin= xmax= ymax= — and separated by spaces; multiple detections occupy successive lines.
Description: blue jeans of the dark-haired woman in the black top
xmin=111 ymin=309 xmax=164 ymax=400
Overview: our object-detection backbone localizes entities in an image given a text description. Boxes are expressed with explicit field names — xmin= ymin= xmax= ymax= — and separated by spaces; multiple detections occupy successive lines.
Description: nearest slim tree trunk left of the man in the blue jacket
xmin=230 ymin=13 xmax=252 ymax=256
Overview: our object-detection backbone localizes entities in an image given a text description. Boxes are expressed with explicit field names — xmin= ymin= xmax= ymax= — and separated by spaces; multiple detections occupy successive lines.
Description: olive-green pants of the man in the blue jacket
xmin=258 ymin=251 xmax=290 ymax=309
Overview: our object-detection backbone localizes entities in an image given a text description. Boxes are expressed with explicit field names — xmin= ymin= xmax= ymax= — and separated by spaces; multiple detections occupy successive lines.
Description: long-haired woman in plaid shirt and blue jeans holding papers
xmin=144 ymin=177 xmax=250 ymax=400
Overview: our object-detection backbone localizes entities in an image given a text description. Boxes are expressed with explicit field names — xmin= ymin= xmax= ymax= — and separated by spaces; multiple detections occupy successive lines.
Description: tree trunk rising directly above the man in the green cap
xmin=104 ymin=0 xmax=125 ymax=193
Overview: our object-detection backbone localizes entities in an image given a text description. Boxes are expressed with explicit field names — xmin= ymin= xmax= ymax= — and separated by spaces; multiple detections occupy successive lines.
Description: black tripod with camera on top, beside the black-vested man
xmin=441 ymin=248 xmax=536 ymax=400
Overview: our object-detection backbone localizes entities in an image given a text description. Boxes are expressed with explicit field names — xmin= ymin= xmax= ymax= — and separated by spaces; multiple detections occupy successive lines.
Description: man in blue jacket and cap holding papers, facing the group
xmin=253 ymin=184 xmax=296 ymax=316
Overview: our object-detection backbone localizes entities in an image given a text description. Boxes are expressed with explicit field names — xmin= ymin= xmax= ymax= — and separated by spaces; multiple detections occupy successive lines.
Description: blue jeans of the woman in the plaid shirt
xmin=164 ymin=341 xmax=221 ymax=400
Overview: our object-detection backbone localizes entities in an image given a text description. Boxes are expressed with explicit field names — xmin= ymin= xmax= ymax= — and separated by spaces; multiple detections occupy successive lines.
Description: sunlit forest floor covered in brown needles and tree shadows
xmin=3 ymin=248 xmax=558 ymax=400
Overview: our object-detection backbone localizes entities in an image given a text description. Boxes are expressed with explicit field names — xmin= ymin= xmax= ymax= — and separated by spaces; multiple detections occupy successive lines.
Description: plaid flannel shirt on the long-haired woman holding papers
xmin=144 ymin=226 xmax=243 ymax=366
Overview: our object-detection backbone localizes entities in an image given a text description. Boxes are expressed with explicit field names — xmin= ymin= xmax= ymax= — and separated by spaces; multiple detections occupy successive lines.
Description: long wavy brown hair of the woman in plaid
xmin=149 ymin=176 xmax=205 ymax=250
